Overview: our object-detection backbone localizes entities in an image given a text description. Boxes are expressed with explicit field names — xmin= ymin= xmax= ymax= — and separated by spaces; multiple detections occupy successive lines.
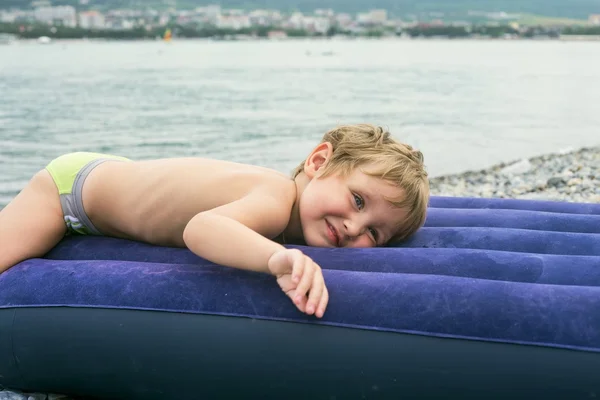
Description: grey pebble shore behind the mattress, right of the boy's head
xmin=430 ymin=146 xmax=600 ymax=203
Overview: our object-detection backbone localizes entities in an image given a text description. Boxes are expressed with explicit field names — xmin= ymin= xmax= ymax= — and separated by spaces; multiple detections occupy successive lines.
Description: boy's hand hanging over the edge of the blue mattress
xmin=268 ymin=249 xmax=329 ymax=318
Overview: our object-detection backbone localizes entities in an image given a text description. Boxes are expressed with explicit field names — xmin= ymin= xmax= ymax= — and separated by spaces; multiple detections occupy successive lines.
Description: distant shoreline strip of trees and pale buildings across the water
xmin=0 ymin=23 xmax=600 ymax=41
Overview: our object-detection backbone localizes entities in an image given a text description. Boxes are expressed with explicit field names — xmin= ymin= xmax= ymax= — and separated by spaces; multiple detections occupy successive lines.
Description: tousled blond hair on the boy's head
xmin=292 ymin=124 xmax=429 ymax=241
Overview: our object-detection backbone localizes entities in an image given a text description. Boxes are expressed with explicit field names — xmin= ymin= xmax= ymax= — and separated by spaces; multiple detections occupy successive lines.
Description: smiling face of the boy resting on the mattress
xmin=299 ymin=156 xmax=406 ymax=247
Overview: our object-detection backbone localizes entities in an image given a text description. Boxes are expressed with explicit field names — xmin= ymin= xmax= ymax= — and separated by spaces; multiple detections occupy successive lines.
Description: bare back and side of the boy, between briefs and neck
xmin=83 ymin=158 xmax=295 ymax=247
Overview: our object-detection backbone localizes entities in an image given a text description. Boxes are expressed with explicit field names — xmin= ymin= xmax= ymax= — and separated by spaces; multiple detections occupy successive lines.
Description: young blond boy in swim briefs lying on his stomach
xmin=0 ymin=125 xmax=429 ymax=318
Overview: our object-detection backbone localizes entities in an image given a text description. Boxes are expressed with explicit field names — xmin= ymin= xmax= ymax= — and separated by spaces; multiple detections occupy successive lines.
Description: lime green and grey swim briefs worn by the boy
xmin=46 ymin=152 xmax=130 ymax=235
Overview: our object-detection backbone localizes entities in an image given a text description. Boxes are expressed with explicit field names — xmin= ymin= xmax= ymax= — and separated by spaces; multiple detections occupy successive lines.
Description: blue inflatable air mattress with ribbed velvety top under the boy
xmin=0 ymin=197 xmax=600 ymax=400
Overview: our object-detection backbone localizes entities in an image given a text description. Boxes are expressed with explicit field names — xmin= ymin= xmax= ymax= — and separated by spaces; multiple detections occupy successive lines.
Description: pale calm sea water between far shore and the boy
xmin=0 ymin=40 xmax=600 ymax=207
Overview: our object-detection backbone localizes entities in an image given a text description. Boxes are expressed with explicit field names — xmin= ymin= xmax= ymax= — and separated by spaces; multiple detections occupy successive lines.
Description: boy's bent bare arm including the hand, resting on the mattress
xmin=183 ymin=182 xmax=329 ymax=318
